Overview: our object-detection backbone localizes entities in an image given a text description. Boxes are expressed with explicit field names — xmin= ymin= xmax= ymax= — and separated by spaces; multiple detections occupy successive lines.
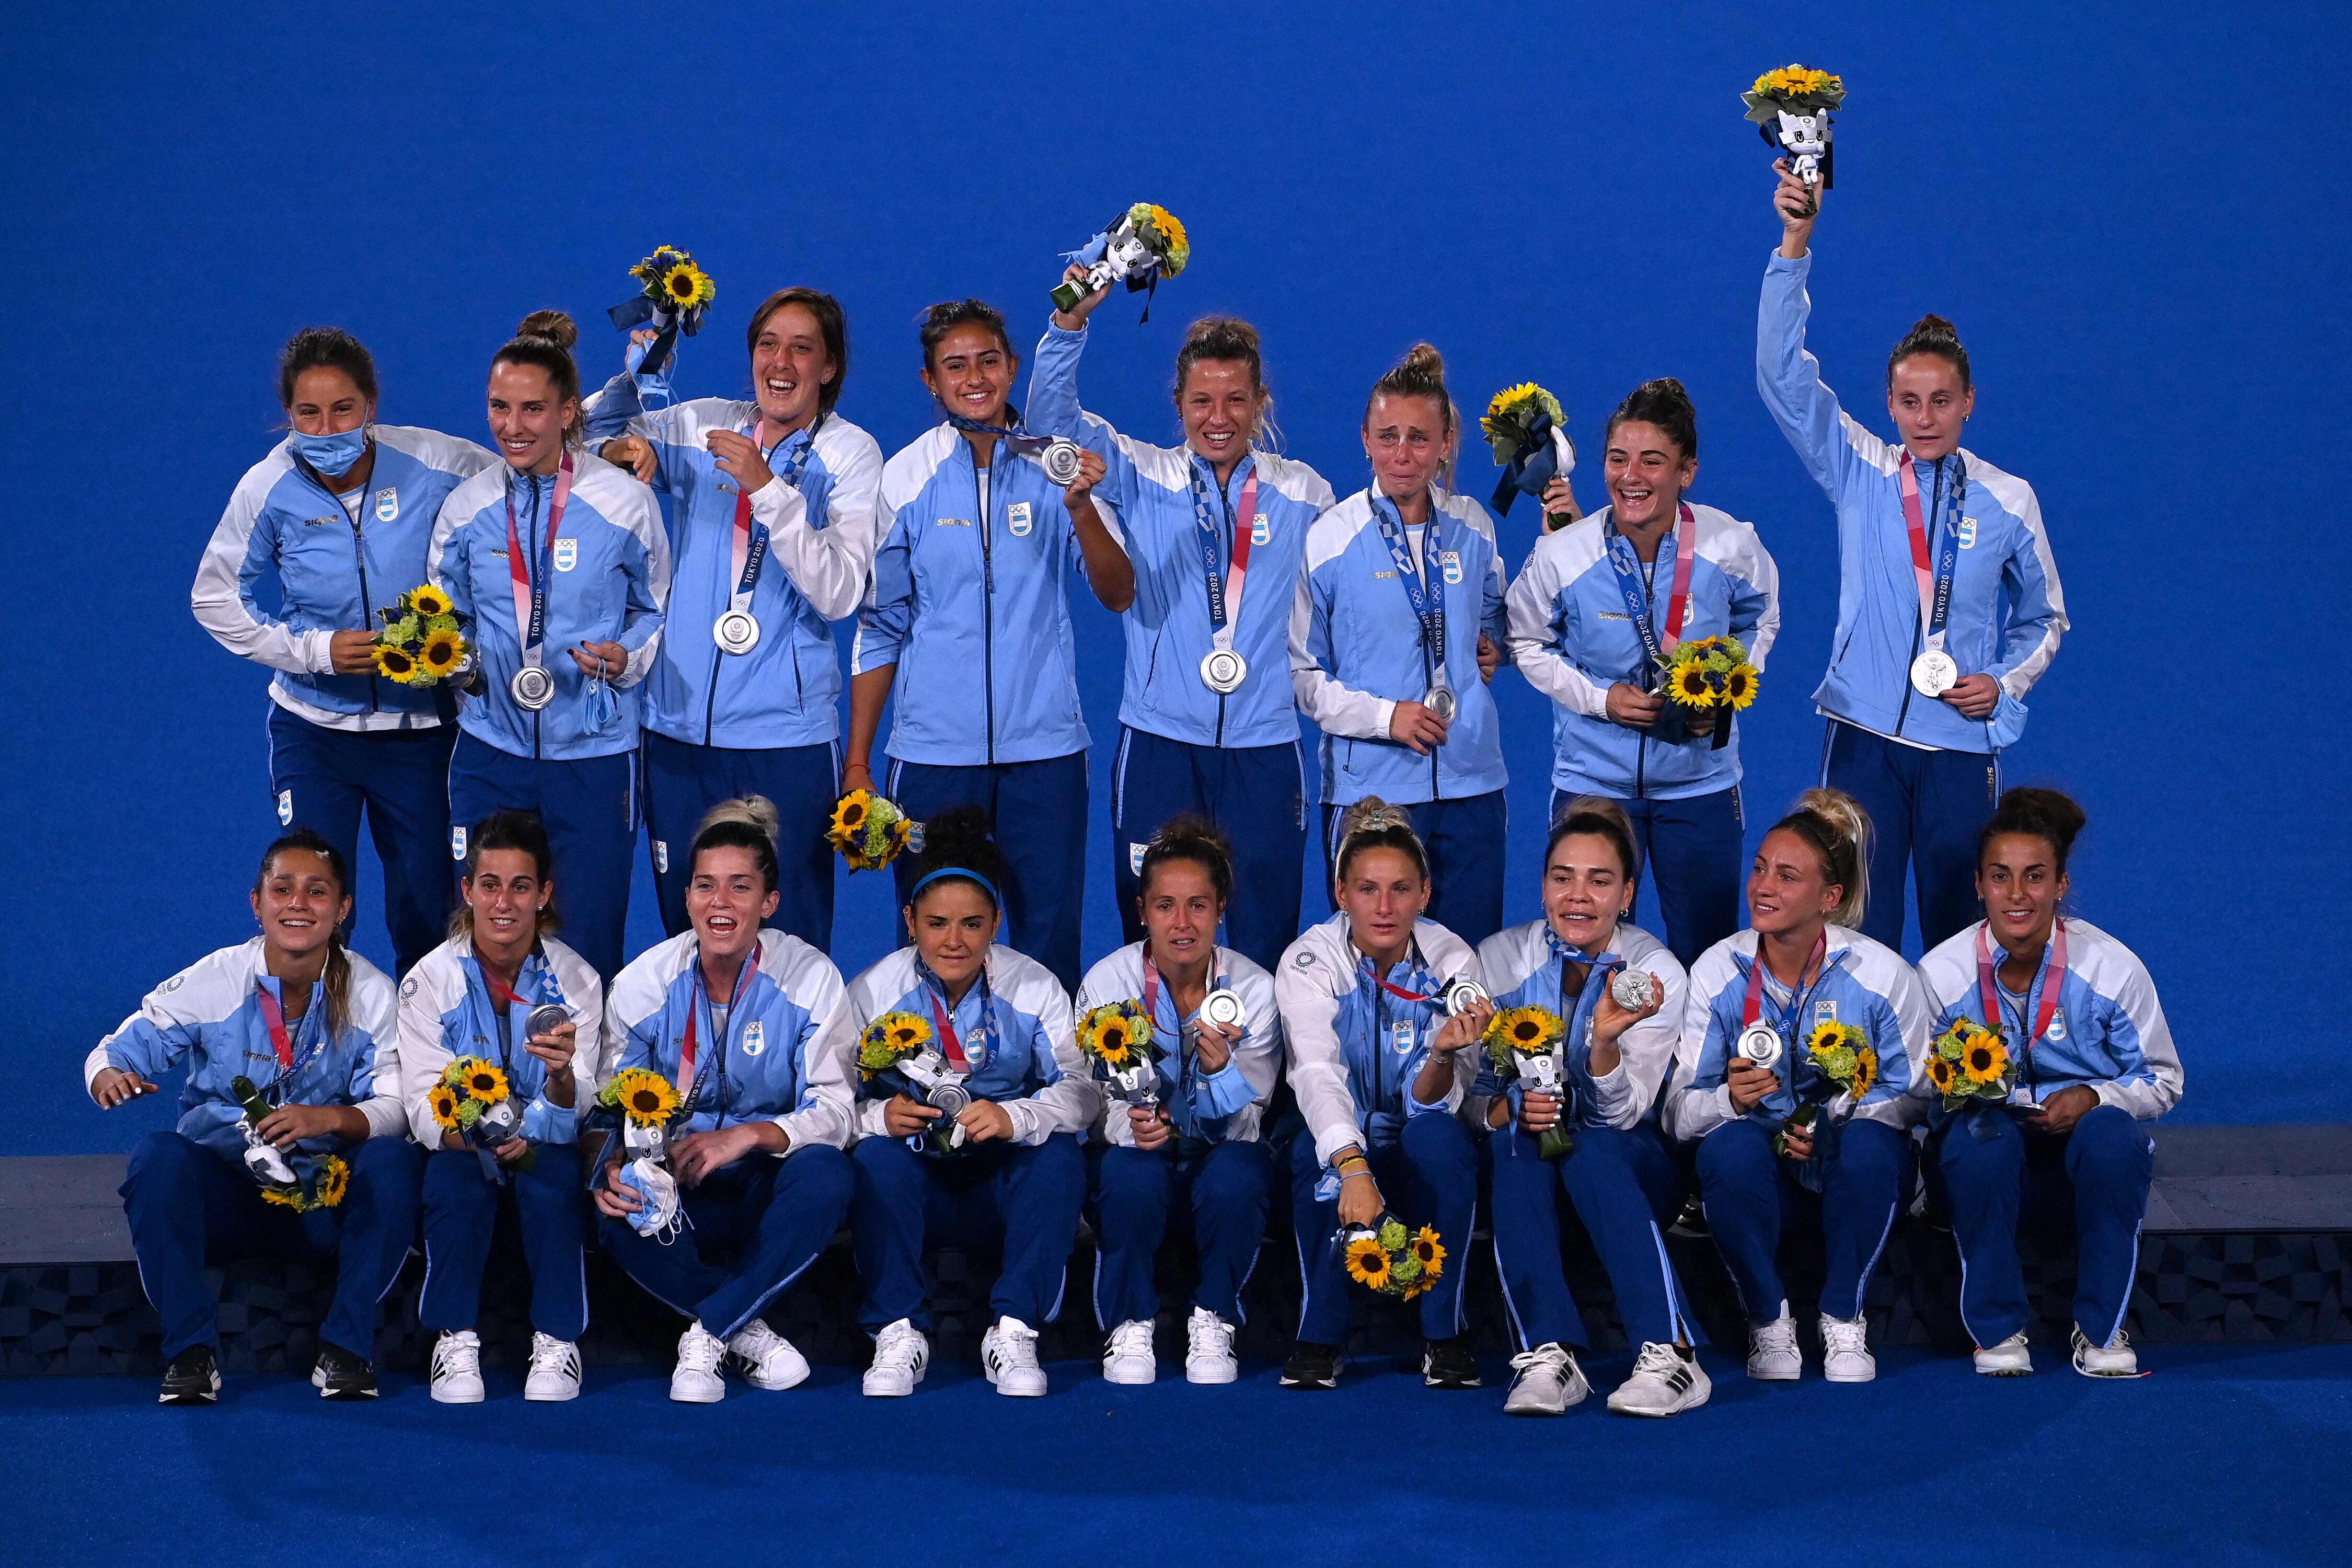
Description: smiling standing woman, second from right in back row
xmin=1510 ymin=378 xmax=1781 ymax=964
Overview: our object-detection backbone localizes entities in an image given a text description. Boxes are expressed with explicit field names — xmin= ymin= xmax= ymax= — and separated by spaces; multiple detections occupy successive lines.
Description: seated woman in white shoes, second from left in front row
xmin=400 ymin=811 xmax=605 ymax=1403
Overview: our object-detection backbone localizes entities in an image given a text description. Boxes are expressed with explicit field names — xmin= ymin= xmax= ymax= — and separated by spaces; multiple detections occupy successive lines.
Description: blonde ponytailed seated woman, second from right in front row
xmin=1665 ymin=790 xmax=1929 ymax=1382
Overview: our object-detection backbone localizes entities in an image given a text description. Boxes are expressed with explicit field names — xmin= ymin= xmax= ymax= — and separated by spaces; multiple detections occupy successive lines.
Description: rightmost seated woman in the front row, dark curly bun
xmin=1919 ymin=790 xmax=2183 ymax=1378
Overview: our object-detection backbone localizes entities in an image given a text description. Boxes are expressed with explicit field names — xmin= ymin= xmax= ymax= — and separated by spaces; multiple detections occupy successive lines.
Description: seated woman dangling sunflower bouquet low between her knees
xmin=1275 ymin=797 xmax=1494 ymax=1389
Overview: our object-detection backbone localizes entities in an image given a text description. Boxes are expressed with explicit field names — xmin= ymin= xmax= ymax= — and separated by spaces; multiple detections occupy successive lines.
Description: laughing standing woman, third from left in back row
xmin=588 ymin=289 xmax=882 ymax=952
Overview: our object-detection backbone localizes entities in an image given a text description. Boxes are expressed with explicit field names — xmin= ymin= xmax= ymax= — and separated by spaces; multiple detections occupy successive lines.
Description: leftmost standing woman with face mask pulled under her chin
xmin=191 ymin=327 xmax=497 ymax=973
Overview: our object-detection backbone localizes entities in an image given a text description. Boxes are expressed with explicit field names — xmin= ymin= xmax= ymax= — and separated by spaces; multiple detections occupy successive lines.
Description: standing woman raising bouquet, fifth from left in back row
xmin=1028 ymin=278 xmax=1331 ymax=966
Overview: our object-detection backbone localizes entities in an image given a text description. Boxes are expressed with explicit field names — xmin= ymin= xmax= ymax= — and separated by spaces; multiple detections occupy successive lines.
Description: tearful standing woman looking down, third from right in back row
xmin=1292 ymin=343 xmax=1508 ymax=943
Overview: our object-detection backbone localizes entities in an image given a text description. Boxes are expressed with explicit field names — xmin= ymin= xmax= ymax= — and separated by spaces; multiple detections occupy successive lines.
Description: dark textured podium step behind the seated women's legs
xmin=0 ymin=1124 xmax=2352 ymax=1375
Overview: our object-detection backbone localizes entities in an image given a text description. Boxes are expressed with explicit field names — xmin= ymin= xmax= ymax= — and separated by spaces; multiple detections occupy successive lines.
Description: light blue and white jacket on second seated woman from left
xmin=400 ymin=936 xmax=605 ymax=1149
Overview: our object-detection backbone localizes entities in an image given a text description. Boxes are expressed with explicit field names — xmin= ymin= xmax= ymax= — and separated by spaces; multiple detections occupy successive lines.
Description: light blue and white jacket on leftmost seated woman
xmin=83 ymin=936 xmax=409 ymax=1159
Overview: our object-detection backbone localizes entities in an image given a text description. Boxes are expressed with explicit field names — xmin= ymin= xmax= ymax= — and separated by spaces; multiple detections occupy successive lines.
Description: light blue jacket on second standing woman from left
xmin=426 ymin=452 xmax=671 ymax=762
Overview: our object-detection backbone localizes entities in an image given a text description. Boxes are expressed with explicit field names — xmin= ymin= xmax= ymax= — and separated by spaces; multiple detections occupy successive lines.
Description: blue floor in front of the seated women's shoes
xmin=0 ymin=1345 xmax=2352 ymax=1568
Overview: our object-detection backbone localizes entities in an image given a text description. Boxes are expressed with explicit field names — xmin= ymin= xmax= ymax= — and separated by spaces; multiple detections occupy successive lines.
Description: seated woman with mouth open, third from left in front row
xmin=595 ymin=797 xmax=849 ymax=1403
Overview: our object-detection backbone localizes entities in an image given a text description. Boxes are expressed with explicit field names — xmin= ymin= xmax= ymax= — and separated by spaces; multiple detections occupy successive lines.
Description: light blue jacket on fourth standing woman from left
xmin=849 ymin=423 xmax=1120 ymax=769
